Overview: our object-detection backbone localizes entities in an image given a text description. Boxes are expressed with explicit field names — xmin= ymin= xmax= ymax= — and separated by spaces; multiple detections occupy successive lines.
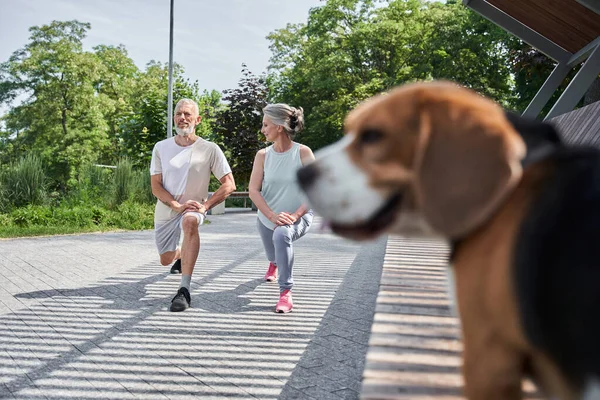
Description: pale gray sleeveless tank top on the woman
xmin=258 ymin=142 xmax=303 ymax=229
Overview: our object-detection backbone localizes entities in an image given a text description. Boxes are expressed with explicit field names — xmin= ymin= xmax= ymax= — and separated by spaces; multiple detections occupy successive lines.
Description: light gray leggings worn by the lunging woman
xmin=257 ymin=211 xmax=313 ymax=292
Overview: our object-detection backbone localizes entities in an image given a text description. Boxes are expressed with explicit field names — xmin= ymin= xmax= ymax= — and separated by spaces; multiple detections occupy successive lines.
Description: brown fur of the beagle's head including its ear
xmin=345 ymin=82 xmax=525 ymax=236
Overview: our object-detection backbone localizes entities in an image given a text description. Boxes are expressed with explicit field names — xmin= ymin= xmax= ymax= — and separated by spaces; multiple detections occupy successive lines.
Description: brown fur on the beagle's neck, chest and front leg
xmin=453 ymin=161 xmax=577 ymax=400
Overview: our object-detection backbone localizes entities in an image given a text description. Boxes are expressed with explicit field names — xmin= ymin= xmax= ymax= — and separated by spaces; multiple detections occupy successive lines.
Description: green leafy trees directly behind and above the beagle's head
xmin=268 ymin=0 xmax=513 ymax=148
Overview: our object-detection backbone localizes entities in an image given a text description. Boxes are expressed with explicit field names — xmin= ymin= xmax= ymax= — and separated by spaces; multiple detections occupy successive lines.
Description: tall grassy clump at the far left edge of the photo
xmin=0 ymin=155 xmax=46 ymax=211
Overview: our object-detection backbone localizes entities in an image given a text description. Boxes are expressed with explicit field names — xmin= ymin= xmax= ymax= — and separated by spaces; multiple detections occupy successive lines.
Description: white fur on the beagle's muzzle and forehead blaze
xmin=307 ymin=134 xmax=385 ymax=224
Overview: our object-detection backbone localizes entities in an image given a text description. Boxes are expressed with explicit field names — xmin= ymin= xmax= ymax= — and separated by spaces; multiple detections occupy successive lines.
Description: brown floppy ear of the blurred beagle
xmin=415 ymin=98 xmax=526 ymax=238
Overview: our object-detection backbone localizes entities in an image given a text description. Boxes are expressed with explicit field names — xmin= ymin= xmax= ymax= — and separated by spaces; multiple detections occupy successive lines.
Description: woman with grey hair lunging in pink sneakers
xmin=249 ymin=104 xmax=315 ymax=313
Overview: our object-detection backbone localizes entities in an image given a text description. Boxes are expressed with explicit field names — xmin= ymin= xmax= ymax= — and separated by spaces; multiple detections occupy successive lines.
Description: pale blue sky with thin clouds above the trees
xmin=0 ymin=0 xmax=323 ymax=91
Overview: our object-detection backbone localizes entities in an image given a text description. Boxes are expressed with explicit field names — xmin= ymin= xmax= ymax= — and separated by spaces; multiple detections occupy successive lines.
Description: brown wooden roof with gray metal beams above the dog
xmin=463 ymin=0 xmax=600 ymax=119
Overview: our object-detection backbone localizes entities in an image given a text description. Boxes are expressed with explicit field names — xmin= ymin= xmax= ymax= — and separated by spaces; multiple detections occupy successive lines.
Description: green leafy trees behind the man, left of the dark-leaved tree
xmin=0 ymin=21 xmax=204 ymax=186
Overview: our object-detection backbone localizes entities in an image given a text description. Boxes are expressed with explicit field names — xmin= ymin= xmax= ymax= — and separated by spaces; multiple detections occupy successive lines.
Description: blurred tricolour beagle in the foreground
xmin=297 ymin=81 xmax=600 ymax=400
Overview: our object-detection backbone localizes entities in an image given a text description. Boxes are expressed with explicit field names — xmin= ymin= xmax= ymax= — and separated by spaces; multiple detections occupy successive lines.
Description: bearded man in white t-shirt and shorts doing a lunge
xmin=150 ymin=99 xmax=235 ymax=311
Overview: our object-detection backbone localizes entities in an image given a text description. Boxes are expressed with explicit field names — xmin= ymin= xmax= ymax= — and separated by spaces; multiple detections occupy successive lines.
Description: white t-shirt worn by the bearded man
xmin=150 ymin=137 xmax=231 ymax=201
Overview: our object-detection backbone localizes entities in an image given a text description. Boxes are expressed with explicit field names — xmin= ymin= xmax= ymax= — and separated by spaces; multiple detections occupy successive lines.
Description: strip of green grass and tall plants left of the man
xmin=0 ymin=156 xmax=218 ymax=238
